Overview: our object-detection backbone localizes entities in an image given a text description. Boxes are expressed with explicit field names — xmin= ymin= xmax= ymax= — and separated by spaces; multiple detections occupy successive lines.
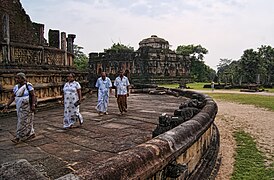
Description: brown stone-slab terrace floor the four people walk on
xmin=0 ymin=94 xmax=185 ymax=179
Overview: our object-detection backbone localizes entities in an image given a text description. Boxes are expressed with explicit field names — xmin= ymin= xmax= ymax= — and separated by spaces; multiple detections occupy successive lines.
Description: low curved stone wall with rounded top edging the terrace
xmin=77 ymin=89 xmax=219 ymax=180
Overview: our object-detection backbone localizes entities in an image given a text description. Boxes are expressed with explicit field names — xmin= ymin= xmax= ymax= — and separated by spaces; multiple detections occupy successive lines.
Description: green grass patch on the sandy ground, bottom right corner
xmin=231 ymin=131 xmax=274 ymax=180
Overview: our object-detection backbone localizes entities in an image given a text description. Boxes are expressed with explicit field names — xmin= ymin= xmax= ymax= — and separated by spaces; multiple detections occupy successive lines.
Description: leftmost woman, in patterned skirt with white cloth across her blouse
xmin=5 ymin=73 xmax=36 ymax=143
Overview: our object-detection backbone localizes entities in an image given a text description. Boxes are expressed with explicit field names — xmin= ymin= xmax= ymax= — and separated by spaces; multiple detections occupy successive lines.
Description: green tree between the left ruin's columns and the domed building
xmin=74 ymin=45 xmax=89 ymax=71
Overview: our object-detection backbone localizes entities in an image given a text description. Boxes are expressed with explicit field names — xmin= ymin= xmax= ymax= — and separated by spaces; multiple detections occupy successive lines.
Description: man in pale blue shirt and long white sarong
xmin=95 ymin=72 xmax=112 ymax=115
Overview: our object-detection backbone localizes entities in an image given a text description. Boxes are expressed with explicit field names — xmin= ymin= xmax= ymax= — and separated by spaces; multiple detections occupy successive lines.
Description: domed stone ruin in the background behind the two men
xmin=89 ymin=35 xmax=190 ymax=86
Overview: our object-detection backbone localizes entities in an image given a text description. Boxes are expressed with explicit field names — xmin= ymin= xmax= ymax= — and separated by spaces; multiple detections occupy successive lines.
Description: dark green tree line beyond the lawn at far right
xmin=217 ymin=45 xmax=274 ymax=86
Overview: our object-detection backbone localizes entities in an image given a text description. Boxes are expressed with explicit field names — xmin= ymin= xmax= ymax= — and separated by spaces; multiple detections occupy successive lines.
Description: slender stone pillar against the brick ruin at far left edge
xmin=2 ymin=14 xmax=10 ymax=62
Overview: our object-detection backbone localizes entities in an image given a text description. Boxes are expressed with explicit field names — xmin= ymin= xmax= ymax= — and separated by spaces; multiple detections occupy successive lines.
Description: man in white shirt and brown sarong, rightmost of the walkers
xmin=114 ymin=70 xmax=130 ymax=115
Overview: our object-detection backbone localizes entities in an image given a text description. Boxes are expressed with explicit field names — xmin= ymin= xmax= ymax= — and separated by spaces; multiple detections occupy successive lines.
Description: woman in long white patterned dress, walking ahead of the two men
xmin=62 ymin=73 xmax=83 ymax=129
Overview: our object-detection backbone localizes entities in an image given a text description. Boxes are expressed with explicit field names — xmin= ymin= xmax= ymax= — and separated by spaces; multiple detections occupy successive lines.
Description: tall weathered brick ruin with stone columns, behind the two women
xmin=0 ymin=0 xmax=87 ymax=112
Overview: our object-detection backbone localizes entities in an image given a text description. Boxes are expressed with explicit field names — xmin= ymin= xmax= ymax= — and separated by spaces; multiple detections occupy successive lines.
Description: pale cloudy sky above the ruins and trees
xmin=21 ymin=0 xmax=274 ymax=70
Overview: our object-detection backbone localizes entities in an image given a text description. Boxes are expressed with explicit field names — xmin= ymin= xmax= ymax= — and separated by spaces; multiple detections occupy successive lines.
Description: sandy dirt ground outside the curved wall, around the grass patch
xmin=215 ymin=100 xmax=274 ymax=180
